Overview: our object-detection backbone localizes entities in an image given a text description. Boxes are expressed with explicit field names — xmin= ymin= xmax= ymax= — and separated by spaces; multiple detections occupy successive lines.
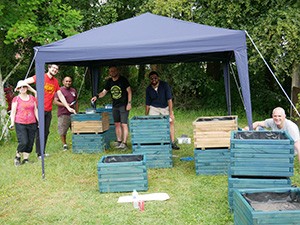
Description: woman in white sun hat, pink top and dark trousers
xmin=9 ymin=80 xmax=38 ymax=166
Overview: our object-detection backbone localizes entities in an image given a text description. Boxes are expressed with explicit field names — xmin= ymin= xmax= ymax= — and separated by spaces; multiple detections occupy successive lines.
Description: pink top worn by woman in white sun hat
xmin=12 ymin=95 xmax=37 ymax=124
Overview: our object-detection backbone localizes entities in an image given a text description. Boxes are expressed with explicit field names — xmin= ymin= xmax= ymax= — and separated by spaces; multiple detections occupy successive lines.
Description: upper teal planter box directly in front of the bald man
xmin=229 ymin=131 xmax=294 ymax=177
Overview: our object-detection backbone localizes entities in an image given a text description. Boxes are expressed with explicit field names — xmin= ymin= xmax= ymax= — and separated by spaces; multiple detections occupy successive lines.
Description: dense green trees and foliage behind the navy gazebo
xmin=0 ymin=0 xmax=300 ymax=118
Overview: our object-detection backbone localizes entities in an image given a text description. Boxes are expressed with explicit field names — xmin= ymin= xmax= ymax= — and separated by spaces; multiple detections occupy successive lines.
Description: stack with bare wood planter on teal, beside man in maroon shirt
xmin=71 ymin=111 xmax=109 ymax=153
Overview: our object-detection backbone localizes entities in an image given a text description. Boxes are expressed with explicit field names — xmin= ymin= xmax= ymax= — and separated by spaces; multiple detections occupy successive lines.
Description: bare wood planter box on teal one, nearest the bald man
xmin=193 ymin=116 xmax=238 ymax=149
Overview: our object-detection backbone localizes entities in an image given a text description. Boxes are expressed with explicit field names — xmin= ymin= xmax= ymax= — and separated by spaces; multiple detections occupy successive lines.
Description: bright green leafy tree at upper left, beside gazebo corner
xmin=0 ymin=0 xmax=82 ymax=143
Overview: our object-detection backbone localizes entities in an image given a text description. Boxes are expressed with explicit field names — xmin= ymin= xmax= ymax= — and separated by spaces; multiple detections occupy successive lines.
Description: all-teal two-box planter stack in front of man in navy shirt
xmin=130 ymin=116 xmax=173 ymax=168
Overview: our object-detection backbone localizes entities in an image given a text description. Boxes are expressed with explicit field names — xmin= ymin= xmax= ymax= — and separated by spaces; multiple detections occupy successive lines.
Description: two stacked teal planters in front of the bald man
xmin=228 ymin=131 xmax=294 ymax=210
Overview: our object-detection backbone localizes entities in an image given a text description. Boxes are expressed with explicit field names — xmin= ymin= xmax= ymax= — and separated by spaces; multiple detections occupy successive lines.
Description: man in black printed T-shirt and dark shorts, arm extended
xmin=91 ymin=66 xmax=132 ymax=149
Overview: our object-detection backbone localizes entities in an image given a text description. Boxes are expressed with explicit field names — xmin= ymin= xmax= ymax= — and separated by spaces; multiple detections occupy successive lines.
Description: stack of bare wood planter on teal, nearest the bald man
xmin=193 ymin=116 xmax=238 ymax=175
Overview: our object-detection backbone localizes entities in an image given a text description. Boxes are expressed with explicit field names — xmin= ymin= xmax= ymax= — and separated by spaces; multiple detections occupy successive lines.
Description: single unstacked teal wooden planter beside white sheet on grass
xmin=98 ymin=154 xmax=148 ymax=192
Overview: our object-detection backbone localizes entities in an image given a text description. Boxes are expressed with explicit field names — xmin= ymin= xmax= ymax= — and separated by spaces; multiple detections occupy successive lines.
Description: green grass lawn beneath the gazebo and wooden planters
xmin=0 ymin=108 xmax=300 ymax=225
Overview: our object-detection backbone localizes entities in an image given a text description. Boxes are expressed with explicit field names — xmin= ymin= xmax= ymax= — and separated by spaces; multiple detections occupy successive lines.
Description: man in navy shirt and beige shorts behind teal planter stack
xmin=145 ymin=71 xmax=180 ymax=150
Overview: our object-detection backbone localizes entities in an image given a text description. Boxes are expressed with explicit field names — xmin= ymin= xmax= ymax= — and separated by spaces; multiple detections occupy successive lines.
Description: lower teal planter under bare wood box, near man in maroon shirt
xmin=72 ymin=133 xmax=108 ymax=153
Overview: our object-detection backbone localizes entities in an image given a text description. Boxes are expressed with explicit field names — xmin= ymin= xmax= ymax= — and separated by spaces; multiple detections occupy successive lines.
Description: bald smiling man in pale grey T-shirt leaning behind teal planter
xmin=244 ymin=107 xmax=300 ymax=162
